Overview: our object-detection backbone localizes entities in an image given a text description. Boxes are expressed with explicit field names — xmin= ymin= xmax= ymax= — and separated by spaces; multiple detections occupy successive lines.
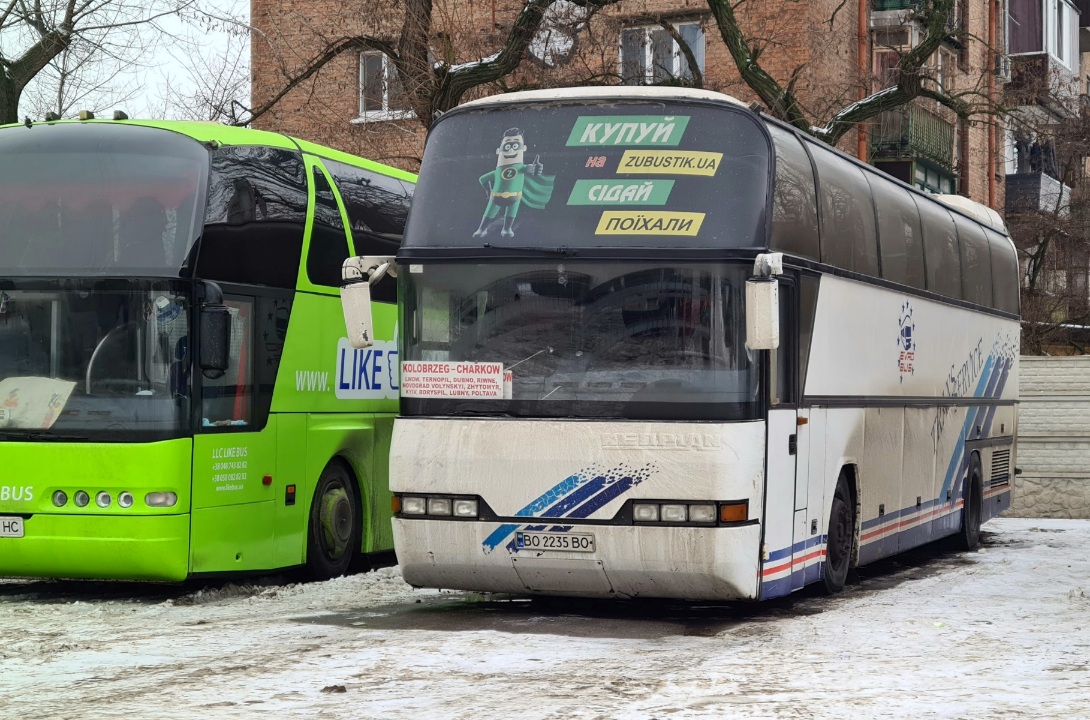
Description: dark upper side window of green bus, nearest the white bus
xmin=322 ymin=159 xmax=414 ymax=303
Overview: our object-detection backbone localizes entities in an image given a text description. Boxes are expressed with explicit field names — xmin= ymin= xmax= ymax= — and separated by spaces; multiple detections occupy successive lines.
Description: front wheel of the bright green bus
xmin=306 ymin=459 xmax=361 ymax=581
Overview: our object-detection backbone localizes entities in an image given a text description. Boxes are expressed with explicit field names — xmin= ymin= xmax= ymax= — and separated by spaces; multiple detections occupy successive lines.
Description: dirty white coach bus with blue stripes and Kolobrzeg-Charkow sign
xmin=344 ymin=87 xmax=1019 ymax=599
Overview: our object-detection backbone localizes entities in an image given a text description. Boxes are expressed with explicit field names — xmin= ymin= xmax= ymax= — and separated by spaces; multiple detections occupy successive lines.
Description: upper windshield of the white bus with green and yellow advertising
xmin=404 ymin=100 xmax=771 ymax=248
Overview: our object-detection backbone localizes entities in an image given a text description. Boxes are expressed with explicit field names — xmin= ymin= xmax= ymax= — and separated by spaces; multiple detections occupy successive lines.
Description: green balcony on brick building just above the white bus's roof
xmin=870 ymin=106 xmax=954 ymax=169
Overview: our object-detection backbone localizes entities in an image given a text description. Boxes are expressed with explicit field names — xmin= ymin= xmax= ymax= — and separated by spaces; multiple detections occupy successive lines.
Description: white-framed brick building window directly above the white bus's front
xmin=620 ymin=23 xmax=704 ymax=85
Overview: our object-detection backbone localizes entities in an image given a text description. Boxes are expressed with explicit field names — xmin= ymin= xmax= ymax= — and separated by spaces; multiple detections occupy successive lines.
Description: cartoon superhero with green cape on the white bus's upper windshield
xmin=473 ymin=127 xmax=555 ymax=237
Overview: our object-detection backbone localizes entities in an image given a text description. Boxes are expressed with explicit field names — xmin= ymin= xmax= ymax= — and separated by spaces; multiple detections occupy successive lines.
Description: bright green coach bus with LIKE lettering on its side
xmin=0 ymin=119 xmax=415 ymax=581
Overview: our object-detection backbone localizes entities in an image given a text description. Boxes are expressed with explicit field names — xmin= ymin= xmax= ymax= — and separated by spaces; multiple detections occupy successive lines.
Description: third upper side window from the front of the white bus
xmin=868 ymin=173 xmax=924 ymax=290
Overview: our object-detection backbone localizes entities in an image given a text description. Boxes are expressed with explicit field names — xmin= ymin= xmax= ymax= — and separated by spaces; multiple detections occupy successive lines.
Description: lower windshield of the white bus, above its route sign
xmin=401 ymin=260 xmax=759 ymax=420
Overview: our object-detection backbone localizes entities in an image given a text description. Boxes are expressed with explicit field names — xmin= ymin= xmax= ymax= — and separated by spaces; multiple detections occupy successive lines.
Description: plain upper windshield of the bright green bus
xmin=0 ymin=123 xmax=208 ymax=278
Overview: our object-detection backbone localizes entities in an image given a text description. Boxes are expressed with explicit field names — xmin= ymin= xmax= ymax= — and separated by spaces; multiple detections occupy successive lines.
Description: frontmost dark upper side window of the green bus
xmin=197 ymin=147 xmax=306 ymax=289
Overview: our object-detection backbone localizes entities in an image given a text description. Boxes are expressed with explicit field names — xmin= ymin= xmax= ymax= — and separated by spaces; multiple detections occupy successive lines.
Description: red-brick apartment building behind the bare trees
xmin=251 ymin=0 xmax=1006 ymax=209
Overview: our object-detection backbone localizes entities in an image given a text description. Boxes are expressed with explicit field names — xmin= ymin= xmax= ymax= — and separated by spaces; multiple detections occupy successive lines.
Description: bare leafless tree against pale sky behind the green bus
xmin=0 ymin=0 xmax=197 ymax=123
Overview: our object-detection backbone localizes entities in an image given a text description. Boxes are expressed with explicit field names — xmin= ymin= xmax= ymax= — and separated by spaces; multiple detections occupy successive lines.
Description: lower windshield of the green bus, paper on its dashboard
xmin=0 ymin=279 xmax=191 ymax=442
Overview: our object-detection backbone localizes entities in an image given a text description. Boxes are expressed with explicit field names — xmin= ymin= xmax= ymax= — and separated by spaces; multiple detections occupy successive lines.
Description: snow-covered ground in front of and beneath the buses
xmin=0 ymin=518 xmax=1090 ymax=720
